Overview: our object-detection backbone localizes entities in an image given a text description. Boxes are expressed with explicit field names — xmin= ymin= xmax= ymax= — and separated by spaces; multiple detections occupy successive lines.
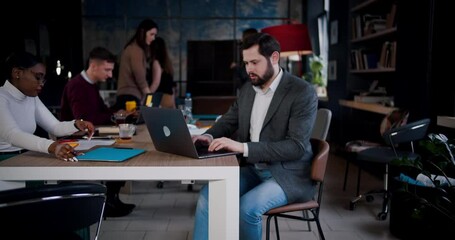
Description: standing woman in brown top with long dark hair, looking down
xmin=115 ymin=19 xmax=158 ymax=109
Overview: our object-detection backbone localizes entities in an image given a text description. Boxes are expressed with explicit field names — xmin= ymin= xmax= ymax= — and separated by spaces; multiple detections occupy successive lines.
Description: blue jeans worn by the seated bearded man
xmin=193 ymin=166 xmax=287 ymax=240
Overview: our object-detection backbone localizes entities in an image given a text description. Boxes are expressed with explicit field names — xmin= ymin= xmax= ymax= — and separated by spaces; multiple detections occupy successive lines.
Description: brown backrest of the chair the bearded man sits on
xmin=310 ymin=138 xmax=330 ymax=182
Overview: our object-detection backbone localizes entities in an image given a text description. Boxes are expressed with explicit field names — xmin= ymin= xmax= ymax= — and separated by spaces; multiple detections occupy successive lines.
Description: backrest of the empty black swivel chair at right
xmin=383 ymin=118 xmax=430 ymax=146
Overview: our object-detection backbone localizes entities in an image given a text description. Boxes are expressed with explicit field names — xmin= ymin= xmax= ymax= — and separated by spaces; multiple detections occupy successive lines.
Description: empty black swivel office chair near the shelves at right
xmin=349 ymin=119 xmax=430 ymax=220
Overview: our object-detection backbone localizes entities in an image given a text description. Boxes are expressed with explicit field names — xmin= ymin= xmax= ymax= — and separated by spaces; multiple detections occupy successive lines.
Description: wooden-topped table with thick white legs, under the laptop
xmin=0 ymin=126 xmax=239 ymax=240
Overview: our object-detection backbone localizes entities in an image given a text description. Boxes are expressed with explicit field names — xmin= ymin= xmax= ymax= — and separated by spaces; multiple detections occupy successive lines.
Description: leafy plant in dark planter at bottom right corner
xmin=390 ymin=133 xmax=455 ymax=239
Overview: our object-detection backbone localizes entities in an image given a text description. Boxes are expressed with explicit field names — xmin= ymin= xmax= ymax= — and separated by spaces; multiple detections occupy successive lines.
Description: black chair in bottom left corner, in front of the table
xmin=0 ymin=183 xmax=106 ymax=240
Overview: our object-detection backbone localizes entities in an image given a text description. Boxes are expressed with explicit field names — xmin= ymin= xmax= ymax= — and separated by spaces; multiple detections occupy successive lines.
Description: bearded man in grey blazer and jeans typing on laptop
xmin=193 ymin=33 xmax=318 ymax=240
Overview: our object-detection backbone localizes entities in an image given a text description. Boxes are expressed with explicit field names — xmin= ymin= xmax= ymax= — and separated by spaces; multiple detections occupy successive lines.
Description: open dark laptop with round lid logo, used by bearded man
xmin=141 ymin=107 xmax=238 ymax=159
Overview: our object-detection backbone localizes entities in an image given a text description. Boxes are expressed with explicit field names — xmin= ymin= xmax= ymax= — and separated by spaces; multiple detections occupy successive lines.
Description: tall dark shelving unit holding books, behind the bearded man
xmin=346 ymin=0 xmax=398 ymax=114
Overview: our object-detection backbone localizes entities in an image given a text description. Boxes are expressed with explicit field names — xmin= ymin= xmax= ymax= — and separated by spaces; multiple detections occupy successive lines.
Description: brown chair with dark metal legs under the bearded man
xmin=264 ymin=138 xmax=330 ymax=240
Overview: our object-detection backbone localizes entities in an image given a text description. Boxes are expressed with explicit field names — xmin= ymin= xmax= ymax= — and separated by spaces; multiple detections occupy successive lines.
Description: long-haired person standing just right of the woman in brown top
xmin=150 ymin=37 xmax=175 ymax=108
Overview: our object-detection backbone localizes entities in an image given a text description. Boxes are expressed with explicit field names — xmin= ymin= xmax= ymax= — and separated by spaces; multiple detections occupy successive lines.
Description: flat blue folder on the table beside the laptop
xmin=77 ymin=147 xmax=145 ymax=162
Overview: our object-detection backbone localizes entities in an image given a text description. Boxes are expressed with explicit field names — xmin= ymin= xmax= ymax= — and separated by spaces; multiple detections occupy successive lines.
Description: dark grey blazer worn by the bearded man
xmin=207 ymin=72 xmax=318 ymax=203
